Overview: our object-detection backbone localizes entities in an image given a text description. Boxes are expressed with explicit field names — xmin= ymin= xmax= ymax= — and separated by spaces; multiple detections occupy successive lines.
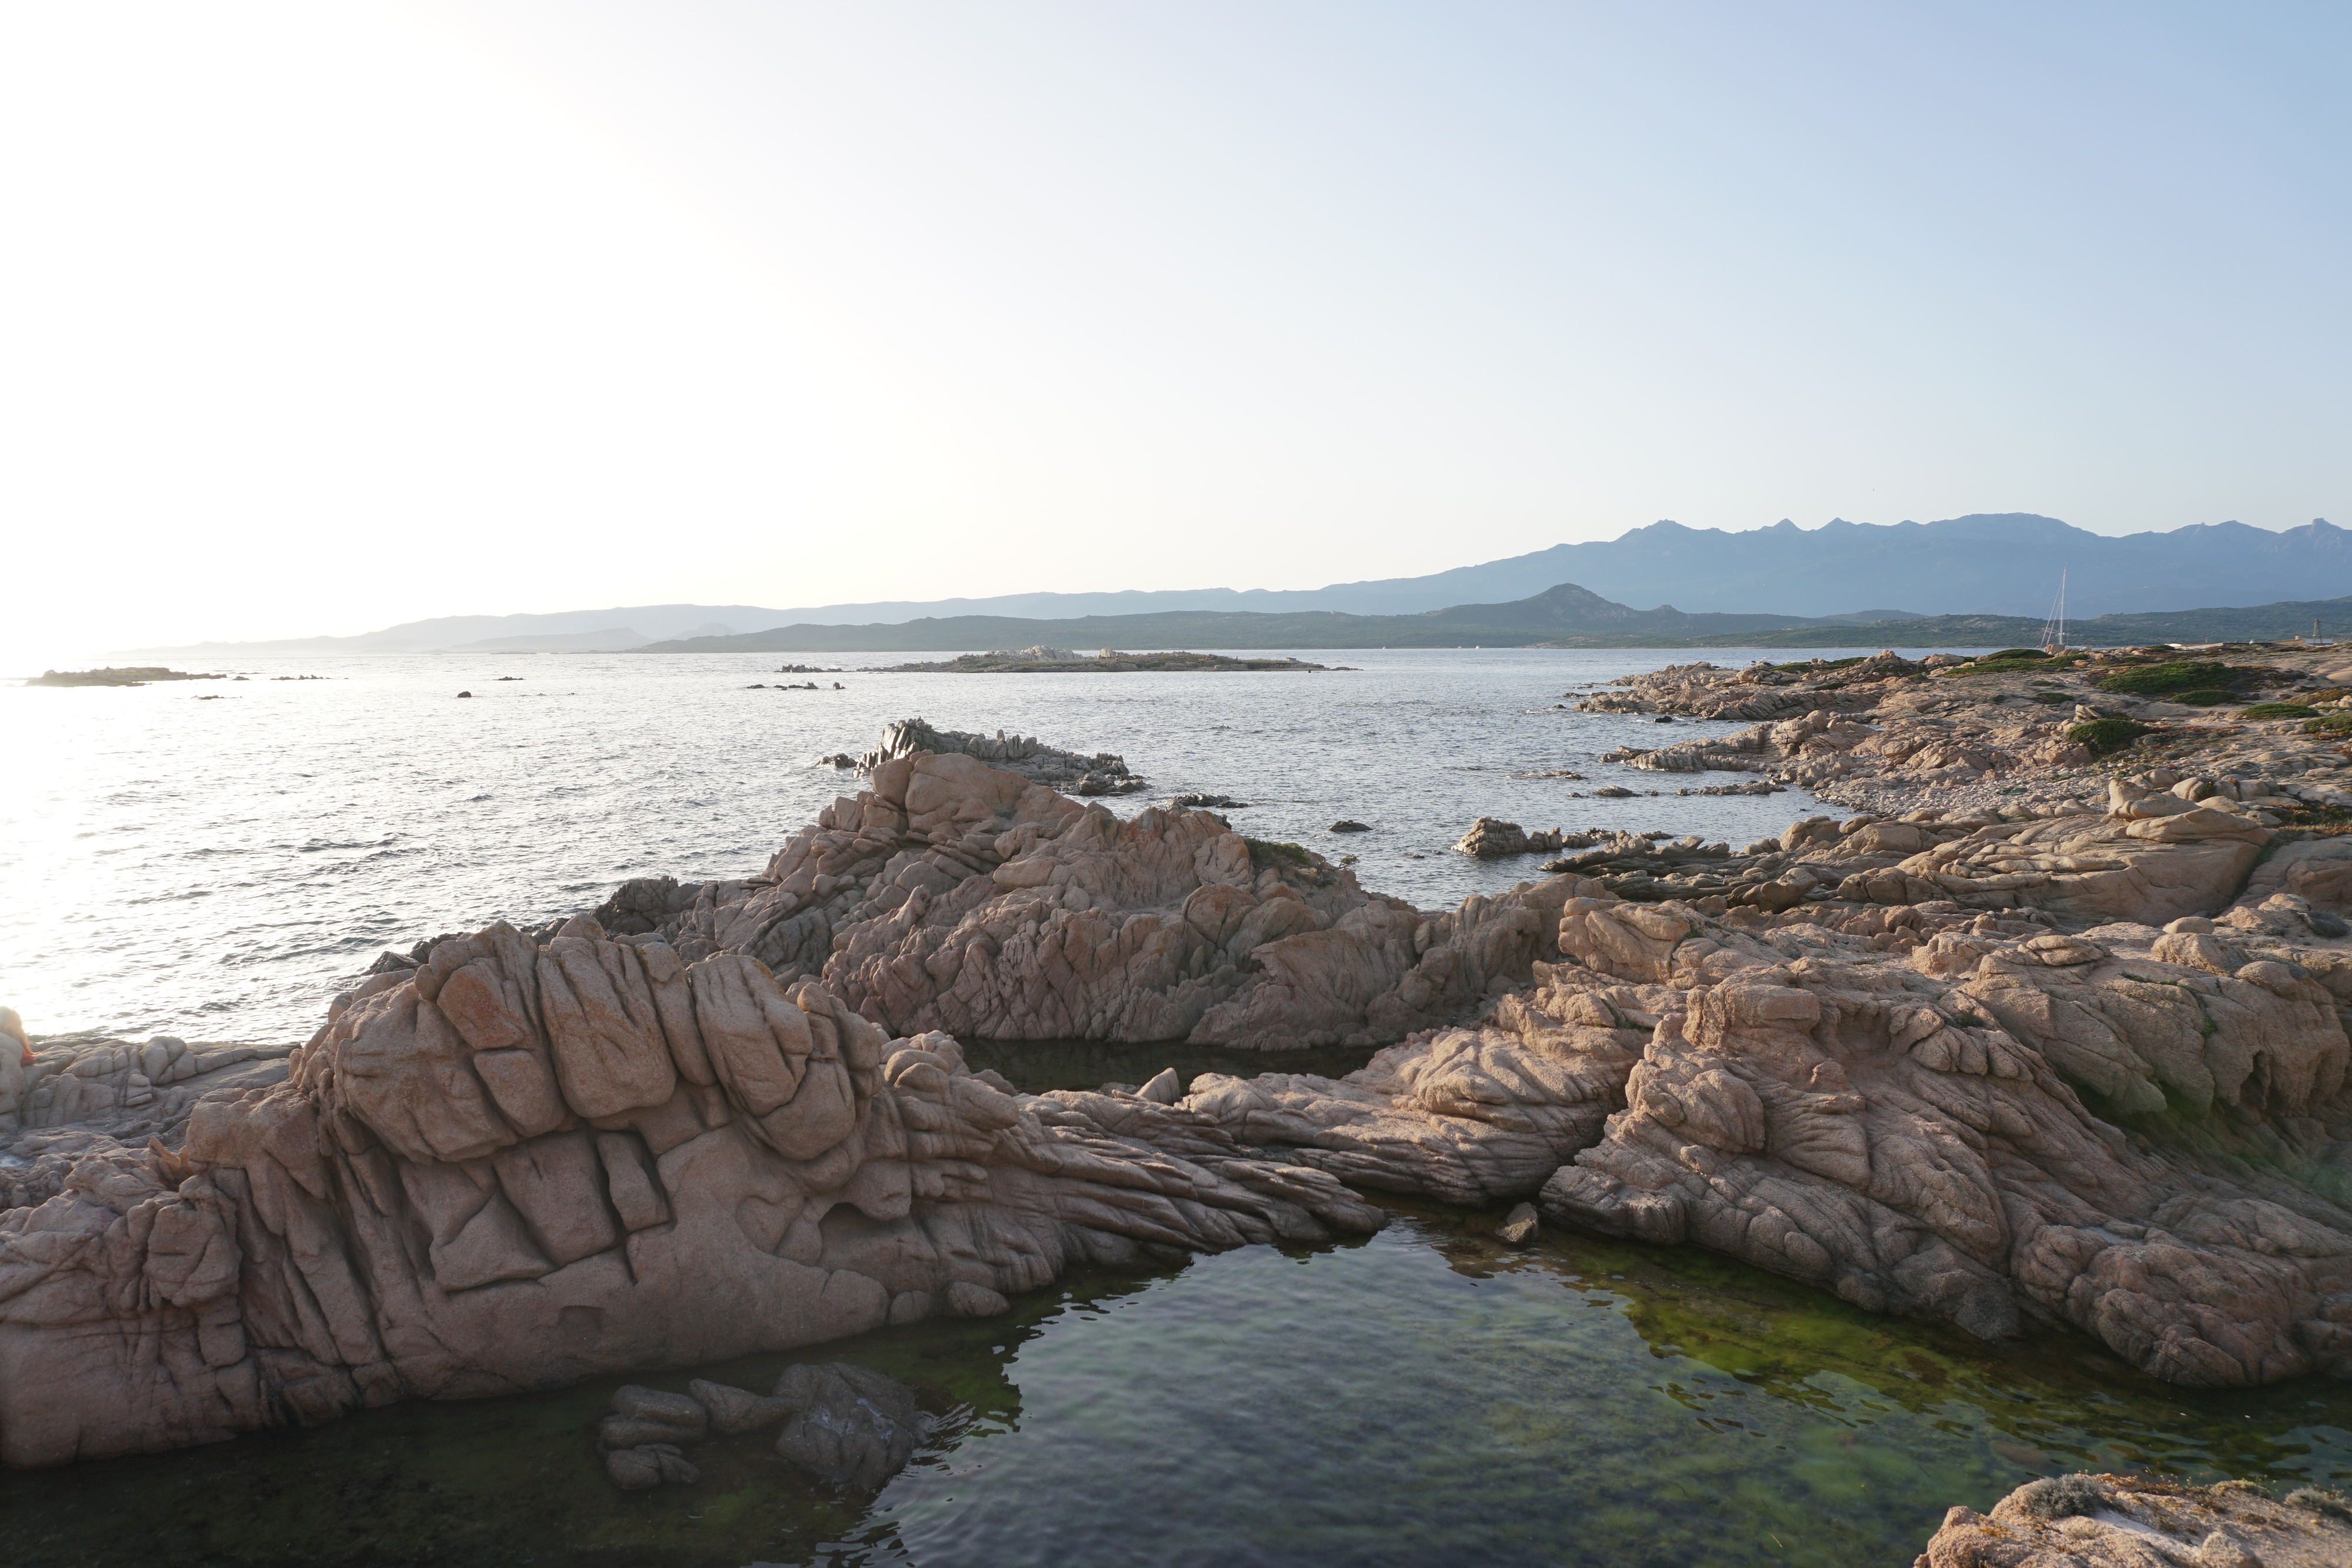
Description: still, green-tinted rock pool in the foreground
xmin=0 ymin=1203 xmax=2352 ymax=1568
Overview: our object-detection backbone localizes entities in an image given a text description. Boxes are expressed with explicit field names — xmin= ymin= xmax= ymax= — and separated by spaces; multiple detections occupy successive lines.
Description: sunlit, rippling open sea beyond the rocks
xmin=0 ymin=649 xmax=1910 ymax=1041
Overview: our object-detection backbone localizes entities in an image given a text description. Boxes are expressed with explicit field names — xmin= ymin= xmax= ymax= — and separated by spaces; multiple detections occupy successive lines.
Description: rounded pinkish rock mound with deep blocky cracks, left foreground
xmin=0 ymin=921 xmax=1381 ymax=1469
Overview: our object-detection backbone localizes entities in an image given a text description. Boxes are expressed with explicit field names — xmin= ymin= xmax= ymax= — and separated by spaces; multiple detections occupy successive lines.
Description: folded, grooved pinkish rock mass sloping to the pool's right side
xmin=1178 ymin=879 xmax=2352 ymax=1385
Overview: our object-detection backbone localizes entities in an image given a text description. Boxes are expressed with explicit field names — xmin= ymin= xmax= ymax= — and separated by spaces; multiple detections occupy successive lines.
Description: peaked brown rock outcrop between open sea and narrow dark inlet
xmin=597 ymin=753 xmax=1571 ymax=1048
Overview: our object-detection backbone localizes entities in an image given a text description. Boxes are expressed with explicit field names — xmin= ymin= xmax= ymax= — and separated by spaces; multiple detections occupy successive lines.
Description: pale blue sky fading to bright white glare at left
xmin=0 ymin=0 xmax=2352 ymax=663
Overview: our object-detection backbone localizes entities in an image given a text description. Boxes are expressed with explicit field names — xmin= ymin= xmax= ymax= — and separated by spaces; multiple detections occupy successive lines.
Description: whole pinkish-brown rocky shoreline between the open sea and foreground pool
xmin=14 ymin=654 xmax=2352 ymax=1563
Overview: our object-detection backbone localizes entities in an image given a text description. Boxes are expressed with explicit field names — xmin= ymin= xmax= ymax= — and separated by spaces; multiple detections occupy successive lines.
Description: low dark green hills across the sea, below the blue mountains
xmin=637 ymin=583 xmax=2352 ymax=654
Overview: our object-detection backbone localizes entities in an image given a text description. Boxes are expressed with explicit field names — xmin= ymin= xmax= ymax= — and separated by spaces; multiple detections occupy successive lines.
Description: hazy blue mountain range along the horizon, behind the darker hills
xmin=122 ymin=513 xmax=2352 ymax=658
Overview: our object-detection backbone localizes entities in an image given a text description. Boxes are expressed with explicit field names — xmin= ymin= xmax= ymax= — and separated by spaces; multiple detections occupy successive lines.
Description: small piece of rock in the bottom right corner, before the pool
xmin=1912 ymin=1474 xmax=2352 ymax=1568
